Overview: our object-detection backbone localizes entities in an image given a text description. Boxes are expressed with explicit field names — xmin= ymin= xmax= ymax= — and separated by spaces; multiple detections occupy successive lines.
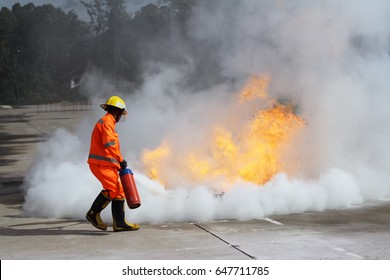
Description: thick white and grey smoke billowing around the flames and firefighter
xmin=24 ymin=0 xmax=390 ymax=223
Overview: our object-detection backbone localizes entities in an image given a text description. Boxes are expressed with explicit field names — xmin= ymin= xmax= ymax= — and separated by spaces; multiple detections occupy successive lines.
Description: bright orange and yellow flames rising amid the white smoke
xmin=142 ymin=75 xmax=304 ymax=188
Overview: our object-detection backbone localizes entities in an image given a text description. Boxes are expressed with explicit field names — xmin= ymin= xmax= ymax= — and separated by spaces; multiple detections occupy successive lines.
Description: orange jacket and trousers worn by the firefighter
xmin=88 ymin=113 xmax=125 ymax=199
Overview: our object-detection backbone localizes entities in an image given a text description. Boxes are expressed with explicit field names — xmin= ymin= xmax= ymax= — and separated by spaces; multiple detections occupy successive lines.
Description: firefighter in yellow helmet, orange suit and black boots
xmin=86 ymin=96 xmax=139 ymax=231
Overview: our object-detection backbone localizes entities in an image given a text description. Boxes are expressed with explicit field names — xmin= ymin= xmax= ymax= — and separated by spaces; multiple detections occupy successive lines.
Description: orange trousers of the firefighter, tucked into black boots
xmin=89 ymin=164 xmax=125 ymax=199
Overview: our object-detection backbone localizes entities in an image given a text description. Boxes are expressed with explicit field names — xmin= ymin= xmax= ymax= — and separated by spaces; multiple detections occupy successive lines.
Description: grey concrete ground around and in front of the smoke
xmin=0 ymin=105 xmax=390 ymax=260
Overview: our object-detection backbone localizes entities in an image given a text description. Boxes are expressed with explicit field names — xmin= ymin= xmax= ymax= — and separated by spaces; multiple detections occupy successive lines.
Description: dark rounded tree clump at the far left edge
xmin=0 ymin=3 xmax=88 ymax=104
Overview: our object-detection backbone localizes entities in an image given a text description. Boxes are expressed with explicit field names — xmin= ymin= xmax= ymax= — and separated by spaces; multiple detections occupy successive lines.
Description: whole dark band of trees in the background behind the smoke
xmin=0 ymin=0 xmax=206 ymax=105
